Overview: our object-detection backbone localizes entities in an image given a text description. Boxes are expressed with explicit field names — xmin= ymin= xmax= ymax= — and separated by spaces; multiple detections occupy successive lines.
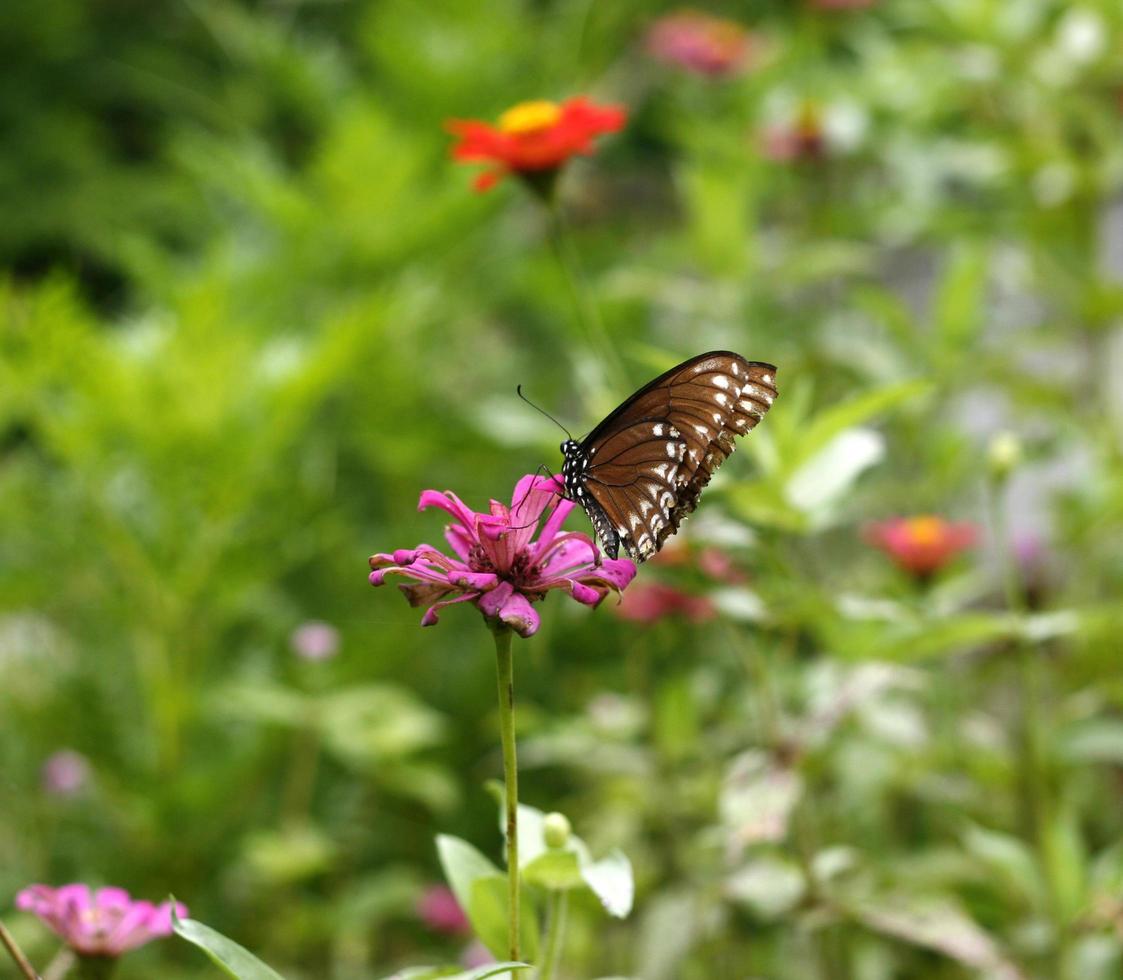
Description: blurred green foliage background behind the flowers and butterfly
xmin=0 ymin=0 xmax=1123 ymax=980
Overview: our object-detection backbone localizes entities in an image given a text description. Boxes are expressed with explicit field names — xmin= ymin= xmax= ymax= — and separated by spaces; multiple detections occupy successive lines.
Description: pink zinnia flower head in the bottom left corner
xmin=16 ymin=885 xmax=188 ymax=956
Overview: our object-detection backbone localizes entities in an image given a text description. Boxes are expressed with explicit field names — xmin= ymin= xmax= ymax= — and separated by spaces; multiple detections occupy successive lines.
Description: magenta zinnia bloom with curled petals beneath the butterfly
xmin=371 ymin=475 xmax=636 ymax=636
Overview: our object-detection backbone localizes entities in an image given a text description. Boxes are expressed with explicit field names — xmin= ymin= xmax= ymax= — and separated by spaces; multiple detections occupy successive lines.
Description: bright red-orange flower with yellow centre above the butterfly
xmin=447 ymin=95 xmax=628 ymax=192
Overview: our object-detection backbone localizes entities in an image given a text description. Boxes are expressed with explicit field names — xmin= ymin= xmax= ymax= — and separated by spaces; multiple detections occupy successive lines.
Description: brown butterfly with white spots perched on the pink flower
xmin=562 ymin=350 xmax=776 ymax=562
